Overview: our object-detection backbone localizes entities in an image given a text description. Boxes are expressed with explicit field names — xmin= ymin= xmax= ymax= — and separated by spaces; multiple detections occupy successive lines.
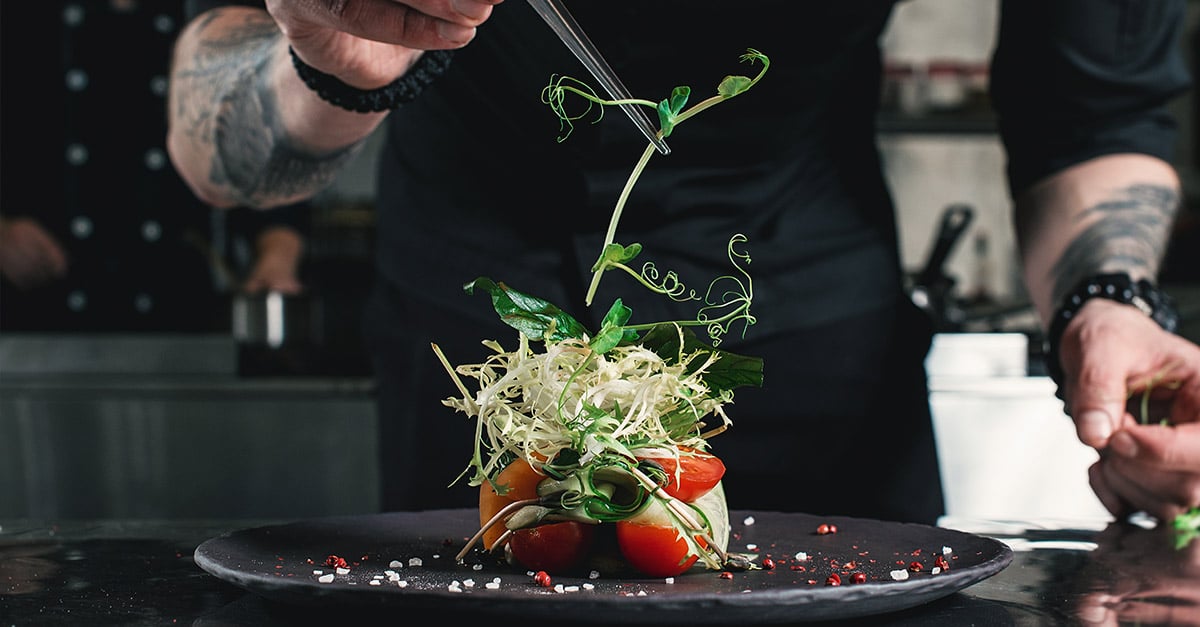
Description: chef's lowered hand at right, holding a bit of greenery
xmin=1060 ymin=299 xmax=1200 ymax=521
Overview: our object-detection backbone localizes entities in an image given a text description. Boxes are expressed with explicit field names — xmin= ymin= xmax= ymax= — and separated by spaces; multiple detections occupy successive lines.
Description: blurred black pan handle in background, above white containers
xmin=908 ymin=204 xmax=974 ymax=332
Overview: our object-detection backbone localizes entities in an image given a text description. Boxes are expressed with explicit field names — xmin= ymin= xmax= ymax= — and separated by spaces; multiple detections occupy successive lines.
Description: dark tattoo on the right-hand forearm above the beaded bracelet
xmin=1051 ymin=185 xmax=1180 ymax=303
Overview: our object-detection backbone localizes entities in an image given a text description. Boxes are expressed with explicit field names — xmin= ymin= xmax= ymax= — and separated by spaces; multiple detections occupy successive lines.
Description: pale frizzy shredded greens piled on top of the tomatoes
xmin=443 ymin=334 xmax=732 ymax=485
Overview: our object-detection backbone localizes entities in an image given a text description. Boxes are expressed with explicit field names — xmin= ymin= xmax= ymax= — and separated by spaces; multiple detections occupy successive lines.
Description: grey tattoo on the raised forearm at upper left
xmin=175 ymin=12 xmax=364 ymax=205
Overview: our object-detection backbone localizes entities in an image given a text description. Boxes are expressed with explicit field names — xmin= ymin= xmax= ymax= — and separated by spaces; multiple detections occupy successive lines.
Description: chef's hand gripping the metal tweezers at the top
xmin=266 ymin=0 xmax=503 ymax=89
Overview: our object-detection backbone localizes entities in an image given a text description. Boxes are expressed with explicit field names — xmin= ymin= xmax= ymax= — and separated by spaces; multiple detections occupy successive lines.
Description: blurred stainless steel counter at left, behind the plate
xmin=0 ymin=338 xmax=379 ymax=519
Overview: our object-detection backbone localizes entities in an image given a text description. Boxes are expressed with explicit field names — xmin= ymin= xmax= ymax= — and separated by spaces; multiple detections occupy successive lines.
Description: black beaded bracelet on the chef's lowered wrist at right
xmin=1045 ymin=273 xmax=1180 ymax=399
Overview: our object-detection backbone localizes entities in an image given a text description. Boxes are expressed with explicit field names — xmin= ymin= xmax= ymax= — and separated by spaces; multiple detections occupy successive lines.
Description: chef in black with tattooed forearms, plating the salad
xmin=168 ymin=0 xmax=1200 ymax=523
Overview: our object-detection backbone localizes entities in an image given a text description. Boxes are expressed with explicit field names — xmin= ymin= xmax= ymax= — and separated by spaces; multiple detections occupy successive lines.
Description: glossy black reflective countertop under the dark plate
xmin=0 ymin=519 xmax=1200 ymax=627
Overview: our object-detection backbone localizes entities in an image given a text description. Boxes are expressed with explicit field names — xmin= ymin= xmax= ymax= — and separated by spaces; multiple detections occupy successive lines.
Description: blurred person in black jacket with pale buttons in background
xmin=0 ymin=0 xmax=306 ymax=333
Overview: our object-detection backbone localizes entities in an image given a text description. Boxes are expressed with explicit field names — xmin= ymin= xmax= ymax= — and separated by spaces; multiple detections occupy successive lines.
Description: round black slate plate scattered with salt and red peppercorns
xmin=196 ymin=509 xmax=1013 ymax=625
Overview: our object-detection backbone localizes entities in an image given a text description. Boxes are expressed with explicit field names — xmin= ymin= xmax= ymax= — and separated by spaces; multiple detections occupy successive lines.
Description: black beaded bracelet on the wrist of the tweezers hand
xmin=288 ymin=46 xmax=454 ymax=113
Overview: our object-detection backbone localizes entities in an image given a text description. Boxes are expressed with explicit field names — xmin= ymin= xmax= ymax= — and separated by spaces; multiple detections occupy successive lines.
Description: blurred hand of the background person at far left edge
xmin=0 ymin=217 xmax=67 ymax=289
